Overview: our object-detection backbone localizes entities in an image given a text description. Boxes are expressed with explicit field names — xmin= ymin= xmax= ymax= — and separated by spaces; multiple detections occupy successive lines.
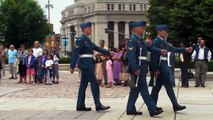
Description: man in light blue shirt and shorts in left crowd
xmin=8 ymin=45 xmax=18 ymax=79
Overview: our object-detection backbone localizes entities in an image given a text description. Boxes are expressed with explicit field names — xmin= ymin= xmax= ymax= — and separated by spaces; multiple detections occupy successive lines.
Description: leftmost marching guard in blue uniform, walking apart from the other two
xmin=70 ymin=22 xmax=110 ymax=111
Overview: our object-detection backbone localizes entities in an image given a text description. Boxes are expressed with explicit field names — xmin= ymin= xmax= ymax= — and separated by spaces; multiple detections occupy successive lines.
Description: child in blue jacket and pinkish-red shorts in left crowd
xmin=25 ymin=49 xmax=36 ymax=84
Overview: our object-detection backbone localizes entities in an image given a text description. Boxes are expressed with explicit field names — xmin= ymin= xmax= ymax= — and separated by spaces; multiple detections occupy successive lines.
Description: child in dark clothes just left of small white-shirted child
xmin=38 ymin=49 xmax=48 ymax=84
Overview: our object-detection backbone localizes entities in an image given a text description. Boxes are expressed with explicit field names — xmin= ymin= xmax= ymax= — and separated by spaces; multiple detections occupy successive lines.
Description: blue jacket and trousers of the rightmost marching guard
xmin=151 ymin=37 xmax=186 ymax=107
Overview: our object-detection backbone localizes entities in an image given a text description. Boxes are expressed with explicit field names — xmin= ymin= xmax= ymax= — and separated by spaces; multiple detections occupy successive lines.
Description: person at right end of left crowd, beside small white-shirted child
xmin=52 ymin=47 xmax=60 ymax=84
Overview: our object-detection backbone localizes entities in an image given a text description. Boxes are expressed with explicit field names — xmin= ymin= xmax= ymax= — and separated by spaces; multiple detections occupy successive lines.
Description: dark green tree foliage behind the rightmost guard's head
xmin=147 ymin=0 xmax=213 ymax=44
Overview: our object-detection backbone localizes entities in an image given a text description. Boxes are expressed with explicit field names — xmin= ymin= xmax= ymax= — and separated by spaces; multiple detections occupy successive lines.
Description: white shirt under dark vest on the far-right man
xmin=192 ymin=47 xmax=212 ymax=62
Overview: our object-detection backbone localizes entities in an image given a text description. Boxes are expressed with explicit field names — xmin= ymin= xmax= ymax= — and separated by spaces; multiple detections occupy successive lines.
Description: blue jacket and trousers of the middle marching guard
xmin=126 ymin=34 xmax=161 ymax=112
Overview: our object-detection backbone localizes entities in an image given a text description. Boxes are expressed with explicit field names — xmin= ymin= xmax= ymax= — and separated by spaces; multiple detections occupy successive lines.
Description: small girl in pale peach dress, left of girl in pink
xmin=96 ymin=56 xmax=103 ymax=85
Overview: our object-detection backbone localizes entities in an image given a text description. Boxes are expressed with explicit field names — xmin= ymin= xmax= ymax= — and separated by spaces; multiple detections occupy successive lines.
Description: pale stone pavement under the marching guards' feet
xmin=0 ymin=72 xmax=213 ymax=120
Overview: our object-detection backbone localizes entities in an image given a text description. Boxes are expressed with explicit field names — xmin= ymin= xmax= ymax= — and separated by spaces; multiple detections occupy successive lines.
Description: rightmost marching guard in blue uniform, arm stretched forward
xmin=151 ymin=25 xmax=192 ymax=111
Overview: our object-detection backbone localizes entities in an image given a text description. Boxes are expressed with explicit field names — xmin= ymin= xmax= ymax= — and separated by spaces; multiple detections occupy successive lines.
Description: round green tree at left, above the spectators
xmin=0 ymin=0 xmax=50 ymax=47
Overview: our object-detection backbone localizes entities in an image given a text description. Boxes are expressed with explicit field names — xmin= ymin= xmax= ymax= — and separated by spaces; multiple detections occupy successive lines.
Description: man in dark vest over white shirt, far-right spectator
xmin=192 ymin=39 xmax=212 ymax=87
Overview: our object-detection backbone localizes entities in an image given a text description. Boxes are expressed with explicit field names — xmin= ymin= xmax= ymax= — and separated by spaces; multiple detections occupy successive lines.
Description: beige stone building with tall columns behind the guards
xmin=61 ymin=0 xmax=149 ymax=54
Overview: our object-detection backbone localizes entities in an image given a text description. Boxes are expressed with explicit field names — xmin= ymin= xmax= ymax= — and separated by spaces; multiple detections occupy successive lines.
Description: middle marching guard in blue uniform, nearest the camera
xmin=126 ymin=21 xmax=167 ymax=116
